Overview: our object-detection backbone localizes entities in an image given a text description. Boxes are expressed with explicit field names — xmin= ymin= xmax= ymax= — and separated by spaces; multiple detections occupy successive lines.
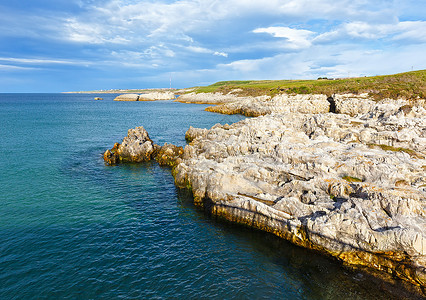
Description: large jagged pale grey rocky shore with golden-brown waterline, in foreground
xmin=104 ymin=92 xmax=426 ymax=295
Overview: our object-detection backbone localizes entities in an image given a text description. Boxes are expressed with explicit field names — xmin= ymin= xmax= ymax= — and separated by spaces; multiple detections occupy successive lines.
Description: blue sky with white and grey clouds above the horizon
xmin=0 ymin=0 xmax=426 ymax=93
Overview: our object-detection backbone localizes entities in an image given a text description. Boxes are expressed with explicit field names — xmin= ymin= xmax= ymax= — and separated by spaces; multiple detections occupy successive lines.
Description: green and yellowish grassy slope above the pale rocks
xmin=191 ymin=70 xmax=426 ymax=99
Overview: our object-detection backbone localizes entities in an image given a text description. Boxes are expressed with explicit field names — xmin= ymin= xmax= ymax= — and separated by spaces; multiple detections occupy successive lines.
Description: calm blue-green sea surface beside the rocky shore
xmin=0 ymin=94 xmax=418 ymax=299
